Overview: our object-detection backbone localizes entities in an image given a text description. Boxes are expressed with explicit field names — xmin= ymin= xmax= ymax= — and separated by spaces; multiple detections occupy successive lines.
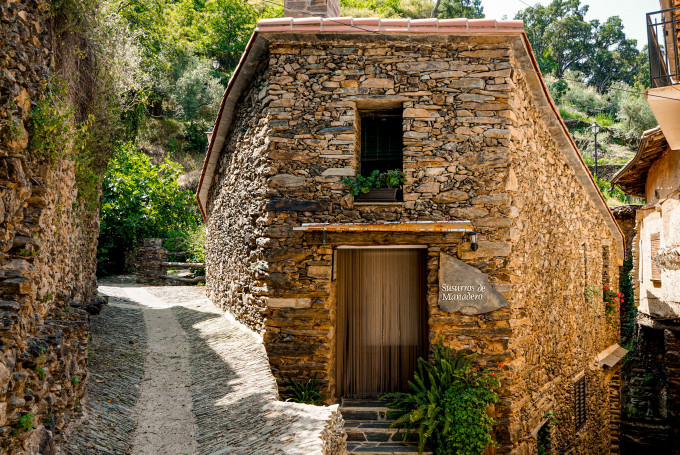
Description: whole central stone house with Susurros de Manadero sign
xmin=197 ymin=2 xmax=624 ymax=454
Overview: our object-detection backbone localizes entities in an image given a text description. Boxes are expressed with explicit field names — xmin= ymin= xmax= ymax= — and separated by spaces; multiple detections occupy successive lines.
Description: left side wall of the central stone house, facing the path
xmin=205 ymin=70 xmax=270 ymax=333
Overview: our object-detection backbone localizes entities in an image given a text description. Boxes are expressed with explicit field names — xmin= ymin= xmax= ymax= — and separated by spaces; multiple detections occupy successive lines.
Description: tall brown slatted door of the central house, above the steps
xmin=337 ymin=248 xmax=427 ymax=398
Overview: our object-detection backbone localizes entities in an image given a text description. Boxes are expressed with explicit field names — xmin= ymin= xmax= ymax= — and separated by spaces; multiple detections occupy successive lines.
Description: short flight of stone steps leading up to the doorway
xmin=340 ymin=398 xmax=432 ymax=455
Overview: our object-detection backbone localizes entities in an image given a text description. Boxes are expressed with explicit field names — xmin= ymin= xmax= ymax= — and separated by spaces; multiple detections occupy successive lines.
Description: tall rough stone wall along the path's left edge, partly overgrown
xmin=0 ymin=0 xmax=101 ymax=454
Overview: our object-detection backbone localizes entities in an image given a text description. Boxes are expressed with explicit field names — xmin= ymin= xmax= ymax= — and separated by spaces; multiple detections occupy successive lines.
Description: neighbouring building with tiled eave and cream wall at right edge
xmin=612 ymin=128 xmax=680 ymax=454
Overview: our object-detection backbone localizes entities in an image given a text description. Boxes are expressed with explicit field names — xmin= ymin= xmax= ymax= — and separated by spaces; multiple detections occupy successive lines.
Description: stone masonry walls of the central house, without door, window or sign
xmin=206 ymin=35 xmax=620 ymax=453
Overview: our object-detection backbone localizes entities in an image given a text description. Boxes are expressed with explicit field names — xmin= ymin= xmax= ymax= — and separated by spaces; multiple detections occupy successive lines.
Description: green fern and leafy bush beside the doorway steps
xmin=383 ymin=339 xmax=502 ymax=455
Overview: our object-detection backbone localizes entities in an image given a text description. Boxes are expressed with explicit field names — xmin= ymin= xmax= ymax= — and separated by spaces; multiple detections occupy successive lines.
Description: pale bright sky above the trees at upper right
xmin=482 ymin=0 xmax=661 ymax=49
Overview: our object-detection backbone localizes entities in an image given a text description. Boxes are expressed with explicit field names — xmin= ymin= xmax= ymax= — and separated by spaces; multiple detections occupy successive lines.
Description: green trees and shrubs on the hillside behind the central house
xmin=98 ymin=0 xmax=656 ymax=272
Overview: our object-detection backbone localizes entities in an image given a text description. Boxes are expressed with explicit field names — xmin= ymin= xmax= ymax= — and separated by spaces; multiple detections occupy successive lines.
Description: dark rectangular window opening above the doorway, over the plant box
xmin=361 ymin=109 xmax=403 ymax=176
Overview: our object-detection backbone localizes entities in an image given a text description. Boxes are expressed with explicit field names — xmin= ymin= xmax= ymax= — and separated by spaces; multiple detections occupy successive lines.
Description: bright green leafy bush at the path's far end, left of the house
xmin=98 ymin=144 xmax=199 ymax=273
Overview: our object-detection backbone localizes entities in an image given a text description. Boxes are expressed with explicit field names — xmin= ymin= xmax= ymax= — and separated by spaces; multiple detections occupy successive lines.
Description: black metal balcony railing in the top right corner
xmin=647 ymin=7 xmax=680 ymax=88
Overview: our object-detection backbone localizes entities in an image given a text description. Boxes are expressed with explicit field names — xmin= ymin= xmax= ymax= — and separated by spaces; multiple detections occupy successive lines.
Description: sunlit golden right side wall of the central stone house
xmin=509 ymin=54 xmax=622 ymax=454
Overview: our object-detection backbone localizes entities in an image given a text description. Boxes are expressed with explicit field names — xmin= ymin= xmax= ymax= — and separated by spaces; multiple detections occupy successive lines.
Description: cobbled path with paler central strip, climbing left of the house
xmin=57 ymin=282 xmax=331 ymax=455
